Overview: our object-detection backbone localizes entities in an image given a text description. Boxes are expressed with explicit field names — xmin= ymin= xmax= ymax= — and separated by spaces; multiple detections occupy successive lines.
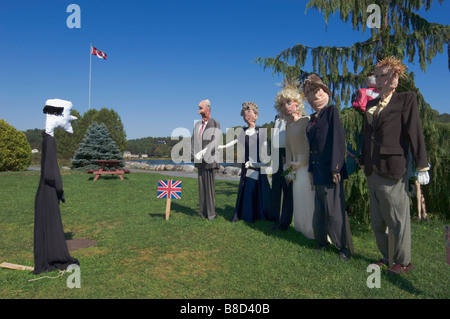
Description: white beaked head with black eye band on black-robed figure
xmin=43 ymin=99 xmax=77 ymax=136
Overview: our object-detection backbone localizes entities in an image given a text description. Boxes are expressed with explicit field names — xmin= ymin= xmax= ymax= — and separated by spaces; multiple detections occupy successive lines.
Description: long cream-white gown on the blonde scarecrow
xmin=286 ymin=116 xmax=315 ymax=239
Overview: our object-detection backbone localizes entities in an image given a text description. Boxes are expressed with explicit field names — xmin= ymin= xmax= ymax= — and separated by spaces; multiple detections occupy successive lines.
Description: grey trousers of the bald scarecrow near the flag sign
xmin=198 ymin=167 xmax=217 ymax=220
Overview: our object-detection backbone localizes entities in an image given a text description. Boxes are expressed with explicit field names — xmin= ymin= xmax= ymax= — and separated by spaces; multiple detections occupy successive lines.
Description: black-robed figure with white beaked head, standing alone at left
xmin=33 ymin=99 xmax=79 ymax=274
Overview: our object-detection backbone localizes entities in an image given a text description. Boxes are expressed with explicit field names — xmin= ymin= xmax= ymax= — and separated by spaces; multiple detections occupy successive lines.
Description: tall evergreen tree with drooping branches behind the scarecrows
xmin=255 ymin=0 xmax=450 ymax=218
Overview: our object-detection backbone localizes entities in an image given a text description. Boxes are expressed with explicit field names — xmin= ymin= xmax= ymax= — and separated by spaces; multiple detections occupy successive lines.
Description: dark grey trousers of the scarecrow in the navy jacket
xmin=313 ymin=181 xmax=347 ymax=250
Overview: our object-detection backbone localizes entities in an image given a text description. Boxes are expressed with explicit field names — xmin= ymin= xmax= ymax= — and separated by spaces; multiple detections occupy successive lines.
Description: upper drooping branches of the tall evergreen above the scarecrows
xmin=255 ymin=0 xmax=450 ymax=106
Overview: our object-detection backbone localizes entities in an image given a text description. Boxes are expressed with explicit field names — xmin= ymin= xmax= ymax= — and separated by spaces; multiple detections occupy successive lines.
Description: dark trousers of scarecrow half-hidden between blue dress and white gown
xmin=272 ymin=148 xmax=294 ymax=228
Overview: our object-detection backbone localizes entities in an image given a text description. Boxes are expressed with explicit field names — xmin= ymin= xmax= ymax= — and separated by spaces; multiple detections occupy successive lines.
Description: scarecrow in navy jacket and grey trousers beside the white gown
xmin=302 ymin=74 xmax=349 ymax=261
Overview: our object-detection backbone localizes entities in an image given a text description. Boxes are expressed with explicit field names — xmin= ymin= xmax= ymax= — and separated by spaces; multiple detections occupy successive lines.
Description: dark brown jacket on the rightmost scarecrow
xmin=360 ymin=92 xmax=428 ymax=179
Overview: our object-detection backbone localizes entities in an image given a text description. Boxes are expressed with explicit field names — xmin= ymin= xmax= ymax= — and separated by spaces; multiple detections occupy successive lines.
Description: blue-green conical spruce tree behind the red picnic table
xmin=70 ymin=122 xmax=124 ymax=171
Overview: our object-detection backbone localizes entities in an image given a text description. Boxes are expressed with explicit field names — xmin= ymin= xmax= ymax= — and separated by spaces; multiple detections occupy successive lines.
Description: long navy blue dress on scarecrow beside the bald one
xmin=232 ymin=128 xmax=276 ymax=223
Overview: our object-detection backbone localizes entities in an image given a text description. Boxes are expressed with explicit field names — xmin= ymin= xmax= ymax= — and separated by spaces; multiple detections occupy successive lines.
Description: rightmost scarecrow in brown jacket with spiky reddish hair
xmin=360 ymin=57 xmax=429 ymax=274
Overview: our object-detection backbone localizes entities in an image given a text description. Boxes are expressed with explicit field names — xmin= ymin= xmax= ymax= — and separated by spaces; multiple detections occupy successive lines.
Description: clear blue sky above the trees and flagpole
xmin=0 ymin=0 xmax=450 ymax=139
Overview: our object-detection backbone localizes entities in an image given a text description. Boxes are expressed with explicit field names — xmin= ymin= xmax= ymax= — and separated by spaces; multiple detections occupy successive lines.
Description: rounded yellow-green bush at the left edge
xmin=0 ymin=119 xmax=31 ymax=171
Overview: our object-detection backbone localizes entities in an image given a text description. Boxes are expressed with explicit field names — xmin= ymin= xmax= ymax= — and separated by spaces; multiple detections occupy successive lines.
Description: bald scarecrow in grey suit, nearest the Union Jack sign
xmin=191 ymin=100 xmax=222 ymax=220
